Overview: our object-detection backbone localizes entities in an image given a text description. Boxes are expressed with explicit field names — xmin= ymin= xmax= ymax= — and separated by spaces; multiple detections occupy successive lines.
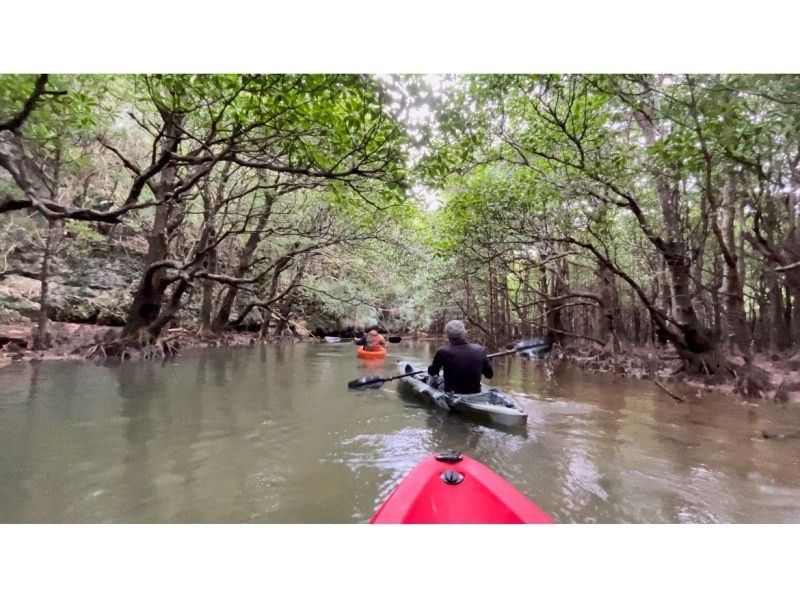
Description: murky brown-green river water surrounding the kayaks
xmin=0 ymin=342 xmax=800 ymax=523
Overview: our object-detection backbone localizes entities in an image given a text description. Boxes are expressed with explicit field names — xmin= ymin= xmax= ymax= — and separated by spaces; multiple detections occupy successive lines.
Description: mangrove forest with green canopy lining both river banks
xmin=0 ymin=75 xmax=800 ymax=400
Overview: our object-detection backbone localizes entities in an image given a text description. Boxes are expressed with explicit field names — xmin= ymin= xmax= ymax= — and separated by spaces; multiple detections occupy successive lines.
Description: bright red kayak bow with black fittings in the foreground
xmin=370 ymin=451 xmax=553 ymax=523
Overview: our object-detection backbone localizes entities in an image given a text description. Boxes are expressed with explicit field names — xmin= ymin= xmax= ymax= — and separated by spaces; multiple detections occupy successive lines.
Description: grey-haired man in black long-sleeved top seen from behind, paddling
xmin=428 ymin=320 xmax=494 ymax=394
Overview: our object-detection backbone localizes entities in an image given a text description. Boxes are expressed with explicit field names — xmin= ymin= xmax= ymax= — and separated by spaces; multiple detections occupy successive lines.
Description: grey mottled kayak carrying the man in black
xmin=397 ymin=361 xmax=528 ymax=427
